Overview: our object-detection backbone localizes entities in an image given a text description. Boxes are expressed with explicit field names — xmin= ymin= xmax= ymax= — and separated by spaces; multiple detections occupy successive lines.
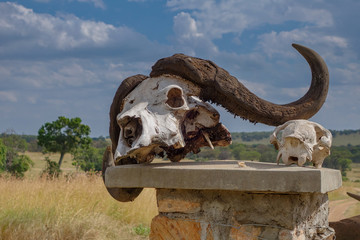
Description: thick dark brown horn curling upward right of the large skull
xmin=150 ymin=44 xmax=329 ymax=126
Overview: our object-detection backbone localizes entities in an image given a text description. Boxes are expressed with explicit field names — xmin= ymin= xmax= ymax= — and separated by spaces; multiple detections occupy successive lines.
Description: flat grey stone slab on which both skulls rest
xmin=105 ymin=161 xmax=342 ymax=193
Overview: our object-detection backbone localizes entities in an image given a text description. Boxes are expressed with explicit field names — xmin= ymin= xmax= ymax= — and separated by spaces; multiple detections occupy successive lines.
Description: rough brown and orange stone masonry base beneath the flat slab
xmin=150 ymin=189 xmax=333 ymax=240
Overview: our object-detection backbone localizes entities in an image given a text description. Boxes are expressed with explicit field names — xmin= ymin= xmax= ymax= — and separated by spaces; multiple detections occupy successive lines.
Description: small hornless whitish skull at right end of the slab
xmin=270 ymin=120 xmax=332 ymax=168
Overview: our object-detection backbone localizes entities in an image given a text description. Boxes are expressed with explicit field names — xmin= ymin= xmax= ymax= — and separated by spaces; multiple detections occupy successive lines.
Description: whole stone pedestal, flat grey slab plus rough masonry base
xmin=105 ymin=161 xmax=341 ymax=240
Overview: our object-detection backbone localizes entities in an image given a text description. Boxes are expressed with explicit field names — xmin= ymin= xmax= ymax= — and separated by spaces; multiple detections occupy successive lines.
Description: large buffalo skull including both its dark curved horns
xmin=103 ymin=44 xmax=329 ymax=201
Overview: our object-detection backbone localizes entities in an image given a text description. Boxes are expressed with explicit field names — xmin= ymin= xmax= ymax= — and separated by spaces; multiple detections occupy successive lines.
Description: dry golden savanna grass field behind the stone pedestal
xmin=0 ymin=153 xmax=360 ymax=240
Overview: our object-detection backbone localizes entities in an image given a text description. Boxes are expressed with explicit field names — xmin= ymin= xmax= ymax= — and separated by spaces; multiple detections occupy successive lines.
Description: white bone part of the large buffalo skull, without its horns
xmin=114 ymin=75 xmax=229 ymax=163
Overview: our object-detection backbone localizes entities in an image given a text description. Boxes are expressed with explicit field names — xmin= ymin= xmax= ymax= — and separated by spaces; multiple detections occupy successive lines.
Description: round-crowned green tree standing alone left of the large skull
xmin=38 ymin=116 xmax=91 ymax=167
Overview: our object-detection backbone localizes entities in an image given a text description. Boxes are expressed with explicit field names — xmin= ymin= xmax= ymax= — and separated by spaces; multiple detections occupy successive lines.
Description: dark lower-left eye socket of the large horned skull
xmin=119 ymin=118 xmax=142 ymax=147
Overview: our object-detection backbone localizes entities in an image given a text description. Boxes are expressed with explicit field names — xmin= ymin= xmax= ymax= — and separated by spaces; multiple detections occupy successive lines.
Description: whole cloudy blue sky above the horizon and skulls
xmin=0 ymin=0 xmax=360 ymax=136
